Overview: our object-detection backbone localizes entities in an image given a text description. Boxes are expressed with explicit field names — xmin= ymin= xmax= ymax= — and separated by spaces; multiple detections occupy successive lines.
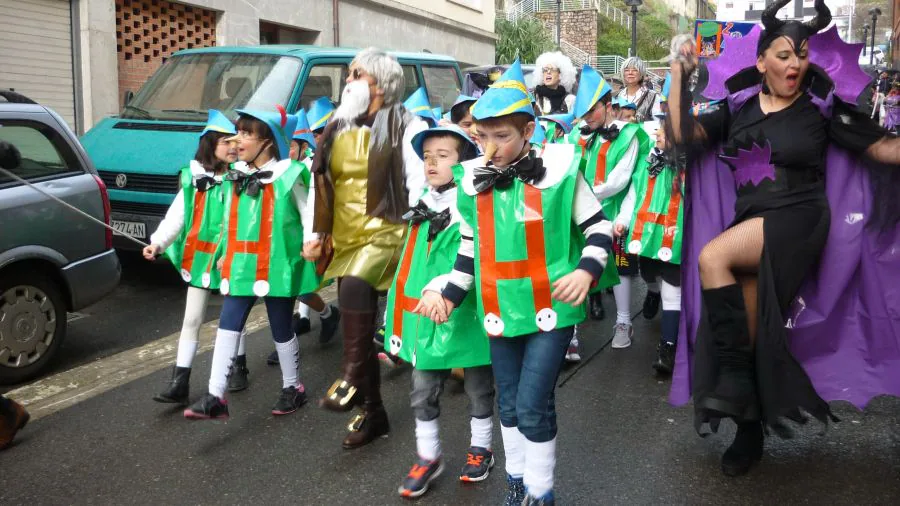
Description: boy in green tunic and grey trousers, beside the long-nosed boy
xmin=385 ymin=125 xmax=494 ymax=498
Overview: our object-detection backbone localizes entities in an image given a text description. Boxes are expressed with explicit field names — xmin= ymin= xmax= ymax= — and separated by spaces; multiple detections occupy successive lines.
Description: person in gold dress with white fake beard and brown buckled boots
xmin=303 ymin=48 xmax=427 ymax=449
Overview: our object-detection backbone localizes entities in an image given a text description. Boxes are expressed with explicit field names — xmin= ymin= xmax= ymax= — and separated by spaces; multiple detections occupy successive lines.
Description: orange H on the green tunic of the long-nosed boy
xmin=476 ymin=185 xmax=552 ymax=336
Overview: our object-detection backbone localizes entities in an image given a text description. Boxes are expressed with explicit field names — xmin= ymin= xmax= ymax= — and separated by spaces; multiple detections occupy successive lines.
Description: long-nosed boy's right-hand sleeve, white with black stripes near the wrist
xmin=572 ymin=177 xmax=612 ymax=280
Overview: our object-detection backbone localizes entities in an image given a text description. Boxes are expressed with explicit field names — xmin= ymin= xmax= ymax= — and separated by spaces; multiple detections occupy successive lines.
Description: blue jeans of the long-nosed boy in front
xmin=491 ymin=327 xmax=575 ymax=443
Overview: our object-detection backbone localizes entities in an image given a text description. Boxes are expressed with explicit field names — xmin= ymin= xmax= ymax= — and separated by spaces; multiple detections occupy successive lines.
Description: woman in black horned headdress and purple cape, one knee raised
xmin=667 ymin=0 xmax=900 ymax=476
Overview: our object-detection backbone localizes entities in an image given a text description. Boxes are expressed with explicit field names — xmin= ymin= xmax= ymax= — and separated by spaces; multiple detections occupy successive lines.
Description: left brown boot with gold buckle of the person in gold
xmin=319 ymin=309 xmax=378 ymax=412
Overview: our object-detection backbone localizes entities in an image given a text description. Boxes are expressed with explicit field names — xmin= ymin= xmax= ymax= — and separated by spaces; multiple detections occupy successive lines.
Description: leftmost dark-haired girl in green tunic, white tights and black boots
xmin=143 ymin=109 xmax=248 ymax=405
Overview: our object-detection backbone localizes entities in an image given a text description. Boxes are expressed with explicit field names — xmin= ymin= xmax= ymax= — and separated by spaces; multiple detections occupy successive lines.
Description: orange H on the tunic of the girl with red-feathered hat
xmin=222 ymin=184 xmax=275 ymax=280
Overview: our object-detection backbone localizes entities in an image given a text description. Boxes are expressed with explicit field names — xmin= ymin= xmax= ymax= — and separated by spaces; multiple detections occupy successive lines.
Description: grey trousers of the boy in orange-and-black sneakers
xmin=409 ymin=365 xmax=494 ymax=422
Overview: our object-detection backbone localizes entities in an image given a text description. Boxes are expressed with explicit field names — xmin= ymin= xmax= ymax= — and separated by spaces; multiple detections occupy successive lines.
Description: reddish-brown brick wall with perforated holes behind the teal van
xmin=115 ymin=0 xmax=216 ymax=105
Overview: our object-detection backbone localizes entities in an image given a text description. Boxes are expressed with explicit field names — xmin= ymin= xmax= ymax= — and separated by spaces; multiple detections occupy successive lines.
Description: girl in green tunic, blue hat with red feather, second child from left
xmin=184 ymin=107 xmax=320 ymax=420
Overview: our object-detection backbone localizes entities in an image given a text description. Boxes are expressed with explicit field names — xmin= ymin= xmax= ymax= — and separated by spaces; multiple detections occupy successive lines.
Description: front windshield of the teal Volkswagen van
xmin=121 ymin=53 xmax=302 ymax=121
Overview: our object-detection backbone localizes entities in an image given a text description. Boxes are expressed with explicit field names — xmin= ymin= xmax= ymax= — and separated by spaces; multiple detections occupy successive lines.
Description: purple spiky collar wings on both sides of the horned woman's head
xmin=702 ymin=25 xmax=871 ymax=104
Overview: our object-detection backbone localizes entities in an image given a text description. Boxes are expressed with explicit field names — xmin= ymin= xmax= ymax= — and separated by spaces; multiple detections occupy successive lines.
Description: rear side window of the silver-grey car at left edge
xmin=0 ymin=121 xmax=81 ymax=185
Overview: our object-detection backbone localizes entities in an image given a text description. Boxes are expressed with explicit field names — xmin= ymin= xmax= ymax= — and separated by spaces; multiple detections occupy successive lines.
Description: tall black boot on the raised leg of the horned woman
xmin=699 ymin=284 xmax=760 ymax=422
